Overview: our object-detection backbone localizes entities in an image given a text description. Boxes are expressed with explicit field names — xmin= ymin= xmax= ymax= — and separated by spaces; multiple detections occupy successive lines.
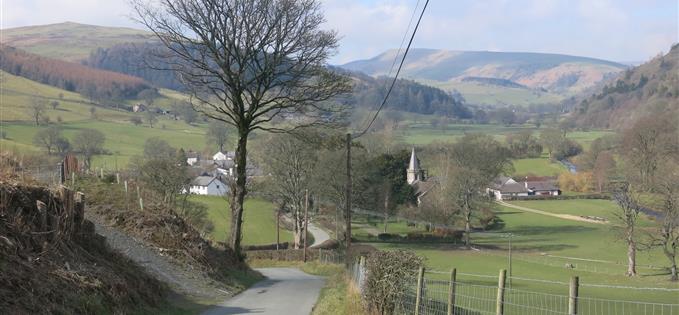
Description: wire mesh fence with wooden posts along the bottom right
xmin=349 ymin=262 xmax=679 ymax=315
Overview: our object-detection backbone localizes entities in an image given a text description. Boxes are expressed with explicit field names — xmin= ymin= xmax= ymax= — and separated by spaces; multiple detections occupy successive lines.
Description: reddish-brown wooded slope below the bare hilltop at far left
xmin=0 ymin=45 xmax=151 ymax=100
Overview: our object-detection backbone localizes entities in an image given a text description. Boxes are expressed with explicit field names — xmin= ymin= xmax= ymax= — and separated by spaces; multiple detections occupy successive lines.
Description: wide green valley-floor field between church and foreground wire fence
xmin=358 ymin=200 xmax=679 ymax=303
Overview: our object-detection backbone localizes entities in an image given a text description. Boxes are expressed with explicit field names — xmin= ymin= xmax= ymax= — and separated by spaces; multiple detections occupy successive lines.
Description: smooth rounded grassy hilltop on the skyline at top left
xmin=2 ymin=22 xmax=153 ymax=61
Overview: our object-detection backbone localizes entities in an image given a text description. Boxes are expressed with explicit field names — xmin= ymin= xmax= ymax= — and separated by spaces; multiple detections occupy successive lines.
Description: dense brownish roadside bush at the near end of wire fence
xmin=363 ymin=250 xmax=424 ymax=314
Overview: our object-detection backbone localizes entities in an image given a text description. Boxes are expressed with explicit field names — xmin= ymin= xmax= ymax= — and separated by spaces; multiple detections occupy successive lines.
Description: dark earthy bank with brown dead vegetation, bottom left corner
xmin=0 ymin=179 xmax=166 ymax=314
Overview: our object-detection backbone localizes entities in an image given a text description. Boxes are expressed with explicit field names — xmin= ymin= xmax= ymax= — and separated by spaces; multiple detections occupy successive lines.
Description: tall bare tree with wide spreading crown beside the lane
xmin=132 ymin=0 xmax=349 ymax=256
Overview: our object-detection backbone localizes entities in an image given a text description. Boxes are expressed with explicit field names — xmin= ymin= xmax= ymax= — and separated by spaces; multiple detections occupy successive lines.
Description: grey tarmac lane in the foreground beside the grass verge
xmin=202 ymin=268 xmax=325 ymax=315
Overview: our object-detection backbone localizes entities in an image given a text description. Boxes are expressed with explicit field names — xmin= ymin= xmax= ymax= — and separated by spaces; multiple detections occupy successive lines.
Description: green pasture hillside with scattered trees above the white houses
xmin=0 ymin=72 xmax=215 ymax=168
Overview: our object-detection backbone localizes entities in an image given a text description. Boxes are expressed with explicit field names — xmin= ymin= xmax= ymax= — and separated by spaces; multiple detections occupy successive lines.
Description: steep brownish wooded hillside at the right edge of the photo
xmin=571 ymin=44 xmax=679 ymax=128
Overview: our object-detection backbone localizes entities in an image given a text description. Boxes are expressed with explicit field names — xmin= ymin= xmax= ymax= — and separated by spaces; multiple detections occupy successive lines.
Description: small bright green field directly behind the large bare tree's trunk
xmin=190 ymin=195 xmax=292 ymax=245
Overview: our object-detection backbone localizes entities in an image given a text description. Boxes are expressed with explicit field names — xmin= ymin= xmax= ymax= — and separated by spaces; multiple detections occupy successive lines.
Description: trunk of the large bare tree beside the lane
xmin=229 ymin=130 xmax=248 ymax=259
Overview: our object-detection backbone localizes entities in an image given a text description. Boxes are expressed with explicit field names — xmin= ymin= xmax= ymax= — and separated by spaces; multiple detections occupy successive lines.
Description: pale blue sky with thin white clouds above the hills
xmin=0 ymin=0 xmax=679 ymax=64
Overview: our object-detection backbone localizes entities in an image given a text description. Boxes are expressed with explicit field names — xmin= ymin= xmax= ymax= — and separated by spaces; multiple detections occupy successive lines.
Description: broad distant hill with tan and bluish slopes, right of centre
xmin=341 ymin=49 xmax=626 ymax=103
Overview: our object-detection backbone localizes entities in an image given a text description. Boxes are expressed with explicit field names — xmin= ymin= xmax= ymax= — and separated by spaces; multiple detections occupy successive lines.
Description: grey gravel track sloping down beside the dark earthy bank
xmin=87 ymin=216 xmax=231 ymax=300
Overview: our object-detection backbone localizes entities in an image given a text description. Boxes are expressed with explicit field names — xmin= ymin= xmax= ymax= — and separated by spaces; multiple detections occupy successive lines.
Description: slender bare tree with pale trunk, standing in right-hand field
xmin=613 ymin=183 xmax=640 ymax=277
